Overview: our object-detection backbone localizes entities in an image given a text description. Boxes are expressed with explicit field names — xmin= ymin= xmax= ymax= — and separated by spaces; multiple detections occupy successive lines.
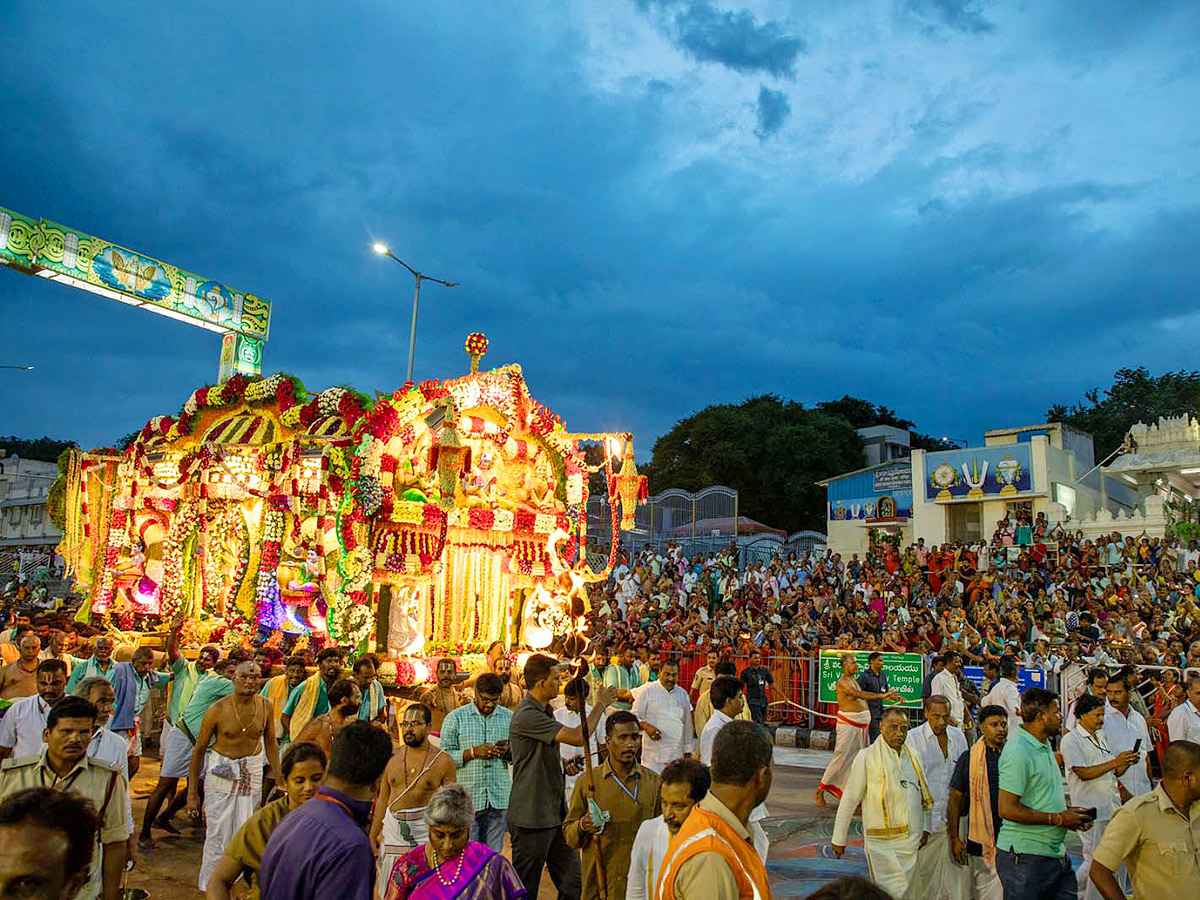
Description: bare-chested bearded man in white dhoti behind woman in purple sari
xmin=371 ymin=703 xmax=456 ymax=884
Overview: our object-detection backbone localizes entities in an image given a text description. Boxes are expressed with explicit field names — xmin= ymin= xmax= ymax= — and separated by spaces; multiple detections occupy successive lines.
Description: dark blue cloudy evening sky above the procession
xmin=0 ymin=0 xmax=1200 ymax=455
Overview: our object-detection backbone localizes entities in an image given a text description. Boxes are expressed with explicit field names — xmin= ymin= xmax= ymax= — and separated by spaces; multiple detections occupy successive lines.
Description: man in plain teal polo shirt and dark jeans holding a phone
xmin=996 ymin=688 xmax=1092 ymax=900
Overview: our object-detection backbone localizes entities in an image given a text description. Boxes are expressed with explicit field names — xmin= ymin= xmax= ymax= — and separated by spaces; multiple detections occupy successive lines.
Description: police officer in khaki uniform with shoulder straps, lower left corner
xmin=0 ymin=697 xmax=130 ymax=900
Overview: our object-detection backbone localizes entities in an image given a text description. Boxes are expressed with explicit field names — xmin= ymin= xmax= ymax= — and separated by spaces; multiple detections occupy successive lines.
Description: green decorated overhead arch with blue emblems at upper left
xmin=0 ymin=206 xmax=271 ymax=373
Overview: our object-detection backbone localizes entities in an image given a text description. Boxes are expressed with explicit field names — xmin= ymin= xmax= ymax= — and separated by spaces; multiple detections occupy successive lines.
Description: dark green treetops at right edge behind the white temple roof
xmin=1046 ymin=366 xmax=1200 ymax=461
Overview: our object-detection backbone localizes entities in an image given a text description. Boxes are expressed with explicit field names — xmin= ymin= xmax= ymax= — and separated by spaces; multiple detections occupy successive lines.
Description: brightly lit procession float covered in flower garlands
xmin=60 ymin=334 xmax=646 ymax=672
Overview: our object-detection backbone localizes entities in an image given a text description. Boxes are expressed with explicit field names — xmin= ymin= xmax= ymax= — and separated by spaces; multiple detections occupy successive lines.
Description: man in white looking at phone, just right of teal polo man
xmin=1062 ymin=694 xmax=1139 ymax=900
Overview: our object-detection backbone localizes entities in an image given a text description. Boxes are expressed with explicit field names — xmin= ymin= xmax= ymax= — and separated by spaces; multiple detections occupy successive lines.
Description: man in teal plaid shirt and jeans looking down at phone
xmin=442 ymin=672 xmax=512 ymax=852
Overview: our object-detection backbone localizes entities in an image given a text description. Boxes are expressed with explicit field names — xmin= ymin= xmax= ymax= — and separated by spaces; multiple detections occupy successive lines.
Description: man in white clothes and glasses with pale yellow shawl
xmin=833 ymin=707 xmax=934 ymax=900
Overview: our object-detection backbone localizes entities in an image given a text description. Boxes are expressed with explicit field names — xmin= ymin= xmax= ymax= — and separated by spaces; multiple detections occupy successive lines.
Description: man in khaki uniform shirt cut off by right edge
xmin=1091 ymin=740 xmax=1200 ymax=900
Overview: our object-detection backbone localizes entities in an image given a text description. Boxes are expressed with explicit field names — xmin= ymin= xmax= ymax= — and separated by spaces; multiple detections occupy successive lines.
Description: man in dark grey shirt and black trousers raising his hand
xmin=508 ymin=653 xmax=617 ymax=900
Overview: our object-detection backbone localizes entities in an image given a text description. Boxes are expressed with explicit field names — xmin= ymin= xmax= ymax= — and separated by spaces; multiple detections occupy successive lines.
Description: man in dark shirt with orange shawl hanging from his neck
xmin=946 ymin=706 xmax=1008 ymax=900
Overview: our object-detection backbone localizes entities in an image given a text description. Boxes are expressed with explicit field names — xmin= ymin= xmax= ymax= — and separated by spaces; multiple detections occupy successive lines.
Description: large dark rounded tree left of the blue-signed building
xmin=643 ymin=394 xmax=863 ymax=532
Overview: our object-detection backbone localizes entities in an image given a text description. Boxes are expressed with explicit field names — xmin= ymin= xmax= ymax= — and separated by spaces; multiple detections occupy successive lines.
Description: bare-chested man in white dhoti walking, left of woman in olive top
xmin=187 ymin=660 xmax=282 ymax=890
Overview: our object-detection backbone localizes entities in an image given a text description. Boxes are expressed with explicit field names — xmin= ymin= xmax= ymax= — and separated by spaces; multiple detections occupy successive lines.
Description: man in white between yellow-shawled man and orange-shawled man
xmin=905 ymin=694 xmax=971 ymax=900
